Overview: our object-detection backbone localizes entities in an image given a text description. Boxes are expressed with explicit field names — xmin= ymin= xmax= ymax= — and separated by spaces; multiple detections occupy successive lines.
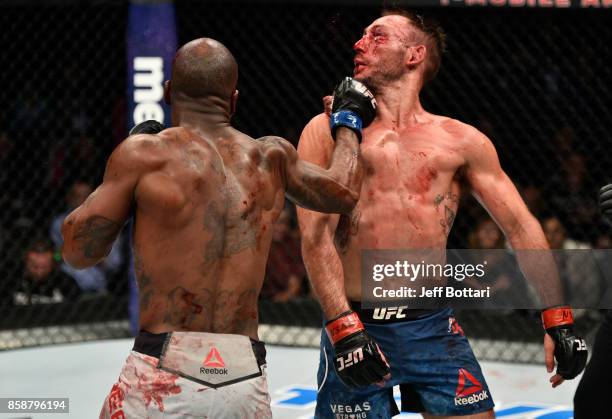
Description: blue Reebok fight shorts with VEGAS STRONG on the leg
xmin=315 ymin=303 xmax=494 ymax=419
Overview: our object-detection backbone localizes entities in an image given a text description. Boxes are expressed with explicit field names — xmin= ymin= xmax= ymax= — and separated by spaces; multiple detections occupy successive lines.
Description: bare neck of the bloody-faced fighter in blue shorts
xmin=376 ymin=84 xmax=427 ymax=129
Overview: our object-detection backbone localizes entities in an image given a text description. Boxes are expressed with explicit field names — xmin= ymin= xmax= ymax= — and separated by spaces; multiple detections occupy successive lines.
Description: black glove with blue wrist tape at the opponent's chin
xmin=330 ymin=77 xmax=376 ymax=142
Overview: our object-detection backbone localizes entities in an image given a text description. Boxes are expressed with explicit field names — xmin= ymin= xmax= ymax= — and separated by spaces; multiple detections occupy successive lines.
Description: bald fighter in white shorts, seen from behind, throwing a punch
xmin=63 ymin=38 xmax=375 ymax=419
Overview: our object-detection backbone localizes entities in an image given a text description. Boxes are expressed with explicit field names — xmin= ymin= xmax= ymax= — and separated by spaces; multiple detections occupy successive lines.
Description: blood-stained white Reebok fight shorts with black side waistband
xmin=100 ymin=331 xmax=272 ymax=419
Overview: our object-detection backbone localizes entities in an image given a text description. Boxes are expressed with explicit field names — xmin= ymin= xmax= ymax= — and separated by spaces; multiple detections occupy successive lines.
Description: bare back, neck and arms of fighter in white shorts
xmin=63 ymin=41 xmax=359 ymax=339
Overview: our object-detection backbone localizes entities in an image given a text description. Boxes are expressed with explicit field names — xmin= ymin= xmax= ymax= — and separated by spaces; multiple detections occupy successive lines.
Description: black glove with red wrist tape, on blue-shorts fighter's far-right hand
xmin=542 ymin=306 xmax=588 ymax=380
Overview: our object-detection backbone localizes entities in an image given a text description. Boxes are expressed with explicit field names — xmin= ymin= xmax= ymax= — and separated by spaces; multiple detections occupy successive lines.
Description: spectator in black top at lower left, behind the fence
xmin=13 ymin=240 xmax=81 ymax=305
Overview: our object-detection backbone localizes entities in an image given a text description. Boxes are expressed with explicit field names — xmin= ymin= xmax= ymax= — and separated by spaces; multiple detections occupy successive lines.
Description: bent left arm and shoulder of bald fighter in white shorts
xmin=62 ymin=134 xmax=165 ymax=268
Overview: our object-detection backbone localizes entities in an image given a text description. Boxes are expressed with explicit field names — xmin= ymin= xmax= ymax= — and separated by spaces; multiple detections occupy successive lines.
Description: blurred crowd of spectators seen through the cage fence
xmin=0 ymin=116 xmax=612 ymax=306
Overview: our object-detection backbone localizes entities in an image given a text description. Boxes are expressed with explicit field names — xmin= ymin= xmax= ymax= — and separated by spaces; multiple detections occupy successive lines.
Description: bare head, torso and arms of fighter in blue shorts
xmin=298 ymin=15 xmax=563 ymax=400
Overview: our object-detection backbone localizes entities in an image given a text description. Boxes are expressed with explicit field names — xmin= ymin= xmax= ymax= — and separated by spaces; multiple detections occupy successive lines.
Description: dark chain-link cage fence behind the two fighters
xmin=0 ymin=0 xmax=612 ymax=362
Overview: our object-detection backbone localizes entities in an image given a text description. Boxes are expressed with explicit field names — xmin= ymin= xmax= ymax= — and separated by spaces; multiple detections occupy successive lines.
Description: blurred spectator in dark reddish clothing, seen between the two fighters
xmin=261 ymin=208 xmax=306 ymax=302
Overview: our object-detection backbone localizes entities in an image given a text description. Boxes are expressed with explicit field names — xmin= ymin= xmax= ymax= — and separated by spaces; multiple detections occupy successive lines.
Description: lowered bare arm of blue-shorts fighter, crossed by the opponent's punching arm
xmin=297 ymin=114 xmax=352 ymax=319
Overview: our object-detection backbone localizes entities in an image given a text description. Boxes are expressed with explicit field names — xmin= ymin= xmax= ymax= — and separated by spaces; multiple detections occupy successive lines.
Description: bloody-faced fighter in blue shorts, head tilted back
xmin=298 ymin=11 xmax=586 ymax=418
